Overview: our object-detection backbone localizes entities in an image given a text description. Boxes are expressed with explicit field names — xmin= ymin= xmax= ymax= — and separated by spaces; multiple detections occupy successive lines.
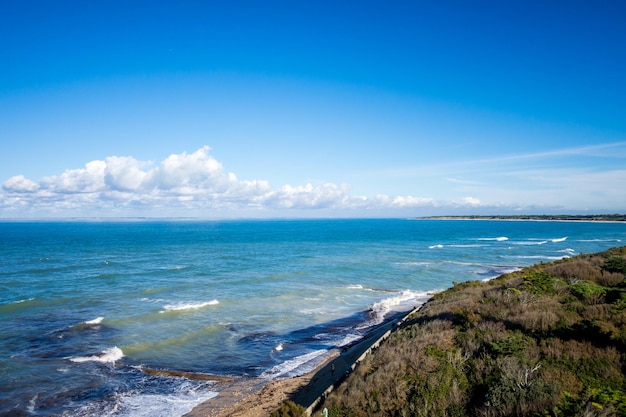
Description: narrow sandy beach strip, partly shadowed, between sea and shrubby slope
xmin=185 ymin=309 xmax=415 ymax=417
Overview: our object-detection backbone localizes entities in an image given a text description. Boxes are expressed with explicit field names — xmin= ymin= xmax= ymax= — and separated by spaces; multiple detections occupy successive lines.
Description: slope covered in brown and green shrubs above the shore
xmin=318 ymin=247 xmax=626 ymax=417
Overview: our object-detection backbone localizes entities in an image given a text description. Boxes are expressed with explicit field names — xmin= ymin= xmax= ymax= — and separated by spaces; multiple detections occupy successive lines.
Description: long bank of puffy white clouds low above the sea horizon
xmin=0 ymin=146 xmax=488 ymax=217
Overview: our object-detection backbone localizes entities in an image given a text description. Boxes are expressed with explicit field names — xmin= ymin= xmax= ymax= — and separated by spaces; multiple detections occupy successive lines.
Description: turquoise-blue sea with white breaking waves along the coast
xmin=0 ymin=220 xmax=626 ymax=416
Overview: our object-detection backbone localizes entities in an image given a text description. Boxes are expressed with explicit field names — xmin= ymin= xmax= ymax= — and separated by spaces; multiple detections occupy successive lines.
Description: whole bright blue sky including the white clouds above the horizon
xmin=0 ymin=0 xmax=626 ymax=218
